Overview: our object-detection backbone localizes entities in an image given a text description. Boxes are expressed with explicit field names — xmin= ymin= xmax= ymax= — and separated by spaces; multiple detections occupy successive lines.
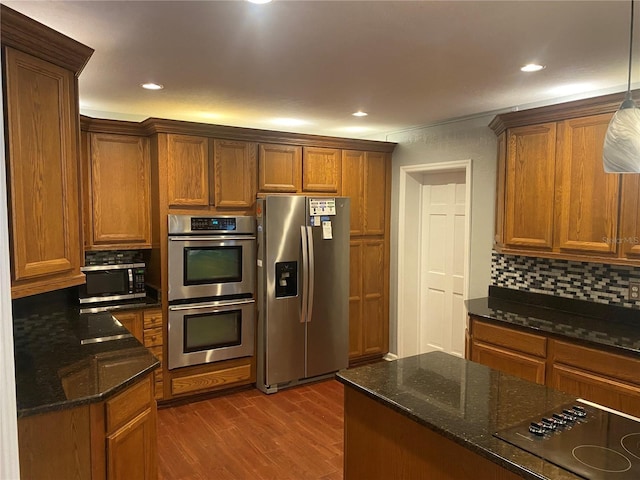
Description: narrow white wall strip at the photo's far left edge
xmin=0 ymin=72 xmax=20 ymax=480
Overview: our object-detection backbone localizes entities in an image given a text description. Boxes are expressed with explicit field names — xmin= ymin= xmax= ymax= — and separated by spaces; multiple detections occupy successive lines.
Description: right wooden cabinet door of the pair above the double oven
xmin=213 ymin=140 xmax=256 ymax=208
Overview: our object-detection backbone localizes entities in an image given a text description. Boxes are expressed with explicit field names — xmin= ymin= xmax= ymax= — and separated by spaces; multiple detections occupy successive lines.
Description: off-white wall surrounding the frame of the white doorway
xmin=386 ymin=115 xmax=497 ymax=353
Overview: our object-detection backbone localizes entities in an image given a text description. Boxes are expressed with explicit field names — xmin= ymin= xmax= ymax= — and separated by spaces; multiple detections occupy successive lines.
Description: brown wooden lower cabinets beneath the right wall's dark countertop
xmin=469 ymin=317 xmax=640 ymax=416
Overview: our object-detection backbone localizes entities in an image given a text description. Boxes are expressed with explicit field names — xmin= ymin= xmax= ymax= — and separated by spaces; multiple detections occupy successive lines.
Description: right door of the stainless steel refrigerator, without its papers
xmin=306 ymin=198 xmax=350 ymax=377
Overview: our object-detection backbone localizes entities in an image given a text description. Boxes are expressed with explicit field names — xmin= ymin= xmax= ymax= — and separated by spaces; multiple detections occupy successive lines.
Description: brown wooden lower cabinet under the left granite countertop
xmin=18 ymin=375 xmax=158 ymax=480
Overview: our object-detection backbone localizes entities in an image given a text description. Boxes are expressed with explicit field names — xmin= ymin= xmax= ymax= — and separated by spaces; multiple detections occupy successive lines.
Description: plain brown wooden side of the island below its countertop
xmin=344 ymin=387 xmax=521 ymax=480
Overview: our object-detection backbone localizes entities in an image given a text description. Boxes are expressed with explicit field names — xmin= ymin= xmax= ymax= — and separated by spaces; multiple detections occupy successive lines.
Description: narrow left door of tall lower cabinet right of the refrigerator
xmin=349 ymin=240 xmax=364 ymax=359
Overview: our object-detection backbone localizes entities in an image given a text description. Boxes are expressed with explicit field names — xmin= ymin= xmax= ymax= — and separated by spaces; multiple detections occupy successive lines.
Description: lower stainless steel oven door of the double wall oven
xmin=167 ymin=299 xmax=255 ymax=370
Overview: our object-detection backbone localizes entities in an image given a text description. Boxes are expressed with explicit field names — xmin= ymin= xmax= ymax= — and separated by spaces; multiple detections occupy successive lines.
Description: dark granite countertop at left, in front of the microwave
xmin=13 ymin=288 xmax=160 ymax=417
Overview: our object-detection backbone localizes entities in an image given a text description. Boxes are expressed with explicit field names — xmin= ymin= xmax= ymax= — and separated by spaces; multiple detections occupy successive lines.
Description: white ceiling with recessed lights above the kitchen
xmin=1 ymin=0 xmax=640 ymax=139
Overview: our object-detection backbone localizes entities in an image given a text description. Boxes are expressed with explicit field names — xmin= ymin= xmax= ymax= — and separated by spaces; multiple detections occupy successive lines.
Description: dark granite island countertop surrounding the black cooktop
xmin=337 ymin=352 xmax=582 ymax=480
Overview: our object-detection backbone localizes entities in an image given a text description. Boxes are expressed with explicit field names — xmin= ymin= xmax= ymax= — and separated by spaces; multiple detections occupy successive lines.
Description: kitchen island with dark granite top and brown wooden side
xmin=337 ymin=352 xmax=581 ymax=480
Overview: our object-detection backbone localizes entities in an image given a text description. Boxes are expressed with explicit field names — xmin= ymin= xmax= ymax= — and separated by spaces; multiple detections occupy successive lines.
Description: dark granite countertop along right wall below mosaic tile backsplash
xmin=465 ymin=287 xmax=640 ymax=356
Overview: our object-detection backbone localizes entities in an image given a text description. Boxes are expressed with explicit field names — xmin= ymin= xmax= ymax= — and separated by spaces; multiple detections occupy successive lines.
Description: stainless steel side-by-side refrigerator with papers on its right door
xmin=256 ymin=195 xmax=350 ymax=393
